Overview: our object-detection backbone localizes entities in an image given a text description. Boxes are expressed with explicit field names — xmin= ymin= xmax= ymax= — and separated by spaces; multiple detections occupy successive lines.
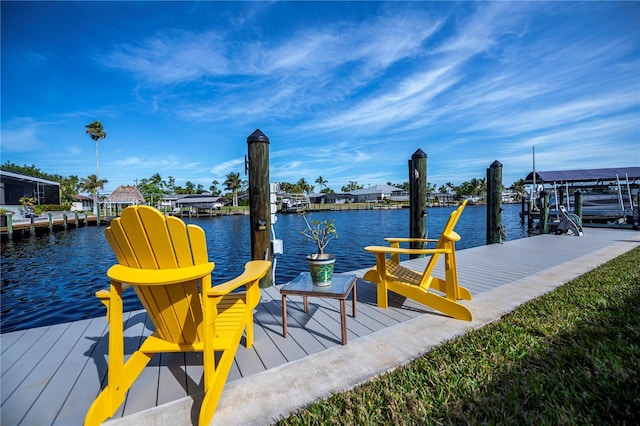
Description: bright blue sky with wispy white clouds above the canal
xmin=0 ymin=1 xmax=640 ymax=192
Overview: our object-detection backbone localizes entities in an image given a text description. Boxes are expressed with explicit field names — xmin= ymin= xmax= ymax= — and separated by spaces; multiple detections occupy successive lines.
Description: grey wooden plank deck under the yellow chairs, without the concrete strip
xmin=0 ymin=229 xmax=640 ymax=426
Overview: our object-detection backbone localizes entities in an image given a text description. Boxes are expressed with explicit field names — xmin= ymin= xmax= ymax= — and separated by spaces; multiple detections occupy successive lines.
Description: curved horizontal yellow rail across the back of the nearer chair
xmin=107 ymin=262 xmax=214 ymax=285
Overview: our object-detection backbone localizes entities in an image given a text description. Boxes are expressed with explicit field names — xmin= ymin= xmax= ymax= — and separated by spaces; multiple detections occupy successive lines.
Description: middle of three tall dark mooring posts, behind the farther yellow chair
xmin=409 ymin=149 xmax=427 ymax=259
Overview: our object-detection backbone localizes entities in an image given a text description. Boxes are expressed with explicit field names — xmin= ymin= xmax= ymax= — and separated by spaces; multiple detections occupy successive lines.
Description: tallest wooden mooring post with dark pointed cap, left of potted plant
xmin=245 ymin=129 xmax=273 ymax=287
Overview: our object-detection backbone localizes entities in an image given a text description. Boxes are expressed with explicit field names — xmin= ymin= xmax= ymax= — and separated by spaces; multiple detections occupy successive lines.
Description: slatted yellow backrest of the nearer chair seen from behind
xmin=105 ymin=206 xmax=208 ymax=344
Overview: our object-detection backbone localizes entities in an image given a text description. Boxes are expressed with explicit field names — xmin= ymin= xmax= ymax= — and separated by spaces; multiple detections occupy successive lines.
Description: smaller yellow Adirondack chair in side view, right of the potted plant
xmin=364 ymin=200 xmax=471 ymax=321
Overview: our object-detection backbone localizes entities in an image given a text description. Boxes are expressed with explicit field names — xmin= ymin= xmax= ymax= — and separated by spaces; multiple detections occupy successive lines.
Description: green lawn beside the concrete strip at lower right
xmin=278 ymin=248 xmax=640 ymax=425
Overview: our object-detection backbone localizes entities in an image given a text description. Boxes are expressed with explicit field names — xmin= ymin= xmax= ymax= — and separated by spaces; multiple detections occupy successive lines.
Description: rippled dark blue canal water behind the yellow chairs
xmin=1 ymin=204 xmax=527 ymax=333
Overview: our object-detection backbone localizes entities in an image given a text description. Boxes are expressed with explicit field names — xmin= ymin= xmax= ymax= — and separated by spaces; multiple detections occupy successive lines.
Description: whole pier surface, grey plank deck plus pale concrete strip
xmin=0 ymin=228 xmax=640 ymax=425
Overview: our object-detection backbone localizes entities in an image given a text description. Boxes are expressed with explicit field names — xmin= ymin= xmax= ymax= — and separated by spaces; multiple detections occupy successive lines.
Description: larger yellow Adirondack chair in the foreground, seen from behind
xmin=85 ymin=206 xmax=271 ymax=425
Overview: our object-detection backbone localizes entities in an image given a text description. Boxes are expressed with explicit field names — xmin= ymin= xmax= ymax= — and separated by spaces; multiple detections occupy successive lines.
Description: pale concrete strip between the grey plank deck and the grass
xmin=108 ymin=230 xmax=640 ymax=425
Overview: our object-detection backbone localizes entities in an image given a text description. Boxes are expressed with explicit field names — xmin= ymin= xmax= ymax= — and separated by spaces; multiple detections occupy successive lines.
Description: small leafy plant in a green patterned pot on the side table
xmin=301 ymin=213 xmax=338 ymax=286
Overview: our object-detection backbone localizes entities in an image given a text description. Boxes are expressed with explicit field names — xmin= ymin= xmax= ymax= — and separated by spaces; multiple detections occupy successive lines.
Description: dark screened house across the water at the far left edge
xmin=0 ymin=170 xmax=60 ymax=207
